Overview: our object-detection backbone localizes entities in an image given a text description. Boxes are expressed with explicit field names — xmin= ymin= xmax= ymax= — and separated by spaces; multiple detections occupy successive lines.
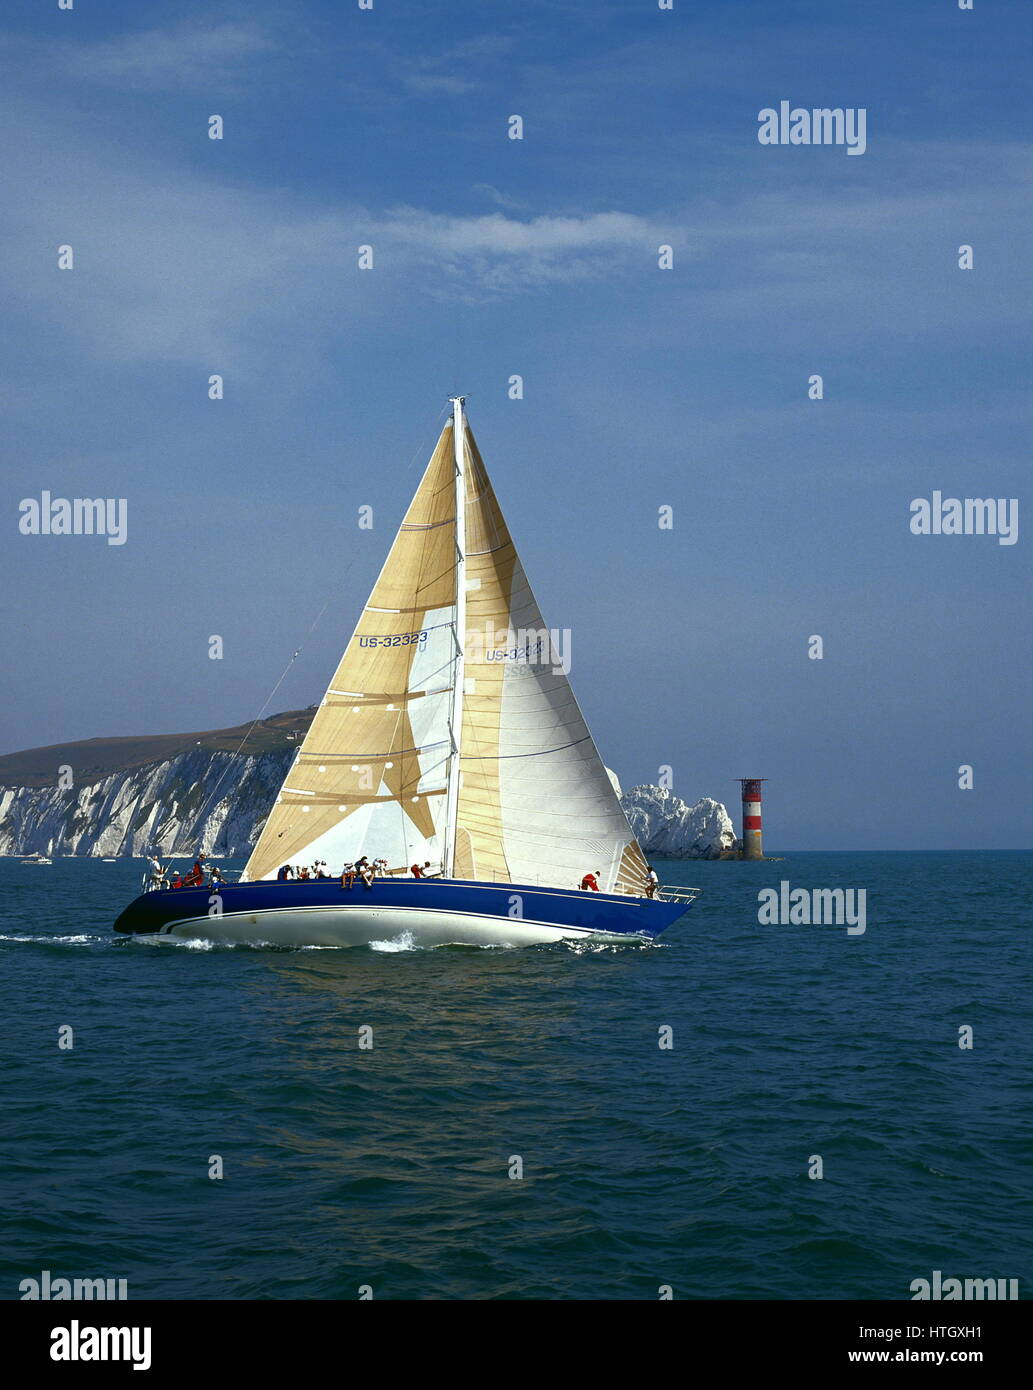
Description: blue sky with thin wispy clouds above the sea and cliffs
xmin=0 ymin=0 xmax=1033 ymax=851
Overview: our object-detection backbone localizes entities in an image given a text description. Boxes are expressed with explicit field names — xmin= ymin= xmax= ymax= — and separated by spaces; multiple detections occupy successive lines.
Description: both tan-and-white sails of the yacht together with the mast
xmin=243 ymin=398 xmax=645 ymax=894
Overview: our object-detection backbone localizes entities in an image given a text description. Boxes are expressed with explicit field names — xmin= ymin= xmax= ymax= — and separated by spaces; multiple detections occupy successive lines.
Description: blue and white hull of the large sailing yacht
xmin=114 ymin=878 xmax=687 ymax=945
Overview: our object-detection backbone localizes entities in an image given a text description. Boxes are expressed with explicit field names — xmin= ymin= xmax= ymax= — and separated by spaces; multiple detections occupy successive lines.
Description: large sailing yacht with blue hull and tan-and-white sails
xmin=114 ymin=396 xmax=706 ymax=945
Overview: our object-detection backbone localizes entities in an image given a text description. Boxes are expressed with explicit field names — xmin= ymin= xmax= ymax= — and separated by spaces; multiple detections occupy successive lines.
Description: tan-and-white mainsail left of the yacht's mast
xmin=243 ymin=423 xmax=456 ymax=878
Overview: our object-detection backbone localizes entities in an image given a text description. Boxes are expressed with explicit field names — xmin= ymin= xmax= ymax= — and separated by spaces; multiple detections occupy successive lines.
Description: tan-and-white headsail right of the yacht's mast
xmin=455 ymin=427 xmax=645 ymax=894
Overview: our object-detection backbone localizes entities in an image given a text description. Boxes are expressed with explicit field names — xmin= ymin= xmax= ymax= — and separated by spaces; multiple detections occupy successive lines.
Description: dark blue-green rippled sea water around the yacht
xmin=0 ymin=851 xmax=1033 ymax=1300
